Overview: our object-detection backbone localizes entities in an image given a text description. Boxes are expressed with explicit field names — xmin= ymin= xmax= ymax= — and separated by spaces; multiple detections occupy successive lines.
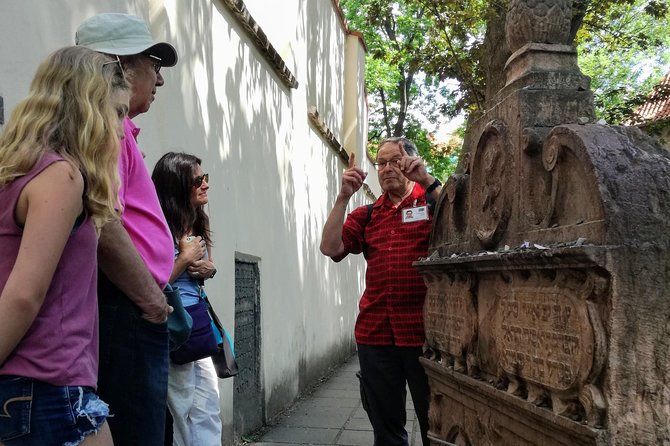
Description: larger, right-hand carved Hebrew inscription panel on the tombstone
xmin=494 ymin=270 xmax=606 ymax=426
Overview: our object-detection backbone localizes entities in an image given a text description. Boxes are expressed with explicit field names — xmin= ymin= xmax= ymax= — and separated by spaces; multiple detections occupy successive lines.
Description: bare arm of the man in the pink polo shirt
xmin=98 ymin=221 xmax=171 ymax=323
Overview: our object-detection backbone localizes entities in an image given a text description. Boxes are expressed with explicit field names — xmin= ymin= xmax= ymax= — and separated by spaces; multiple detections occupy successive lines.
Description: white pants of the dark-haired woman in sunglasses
xmin=168 ymin=358 xmax=221 ymax=446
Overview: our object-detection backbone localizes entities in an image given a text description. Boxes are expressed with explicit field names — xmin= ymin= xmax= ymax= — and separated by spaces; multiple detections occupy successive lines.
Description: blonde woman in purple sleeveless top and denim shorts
xmin=0 ymin=47 xmax=129 ymax=446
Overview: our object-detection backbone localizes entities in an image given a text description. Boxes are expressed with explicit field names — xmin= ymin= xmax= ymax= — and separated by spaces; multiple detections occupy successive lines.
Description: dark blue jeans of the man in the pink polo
xmin=98 ymin=271 xmax=169 ymax=446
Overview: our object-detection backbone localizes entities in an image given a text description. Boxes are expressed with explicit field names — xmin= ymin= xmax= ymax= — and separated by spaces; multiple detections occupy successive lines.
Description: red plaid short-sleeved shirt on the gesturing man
xmin=333 ymin=184 xmax=432 ymax=347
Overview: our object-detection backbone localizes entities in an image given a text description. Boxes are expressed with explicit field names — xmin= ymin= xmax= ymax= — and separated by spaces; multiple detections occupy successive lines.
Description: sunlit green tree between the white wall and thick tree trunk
xmin=342 ymin=0 xmax=464 ymax=178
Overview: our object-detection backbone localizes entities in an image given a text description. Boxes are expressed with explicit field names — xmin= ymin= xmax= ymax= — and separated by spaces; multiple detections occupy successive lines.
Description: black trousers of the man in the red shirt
xmin=358 ymin=344 xmax=430 ymax=446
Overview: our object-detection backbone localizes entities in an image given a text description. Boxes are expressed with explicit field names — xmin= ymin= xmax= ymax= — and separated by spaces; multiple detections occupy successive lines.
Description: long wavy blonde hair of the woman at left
xmin=0 ymin=46 xmax=128 ymax=228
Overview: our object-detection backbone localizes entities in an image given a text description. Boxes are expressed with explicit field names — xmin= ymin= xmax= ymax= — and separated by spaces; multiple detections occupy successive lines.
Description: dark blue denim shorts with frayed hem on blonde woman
xmin=0 ymin=375 xmax=109 ymax=446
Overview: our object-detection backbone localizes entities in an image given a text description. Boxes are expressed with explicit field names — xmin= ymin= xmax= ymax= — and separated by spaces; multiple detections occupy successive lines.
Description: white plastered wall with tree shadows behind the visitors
xmin=0 ymin=0 xmax=379 ymax=436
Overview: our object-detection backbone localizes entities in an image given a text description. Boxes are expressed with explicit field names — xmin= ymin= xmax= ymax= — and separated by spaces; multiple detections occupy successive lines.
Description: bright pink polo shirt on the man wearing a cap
xmin=119 ymin=118 xmax=174 ymax=288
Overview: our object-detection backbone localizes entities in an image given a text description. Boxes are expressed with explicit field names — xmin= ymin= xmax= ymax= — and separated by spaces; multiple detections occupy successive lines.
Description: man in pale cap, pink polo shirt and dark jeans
xmin=75 ymin=13 xmax=177 ymax=446
